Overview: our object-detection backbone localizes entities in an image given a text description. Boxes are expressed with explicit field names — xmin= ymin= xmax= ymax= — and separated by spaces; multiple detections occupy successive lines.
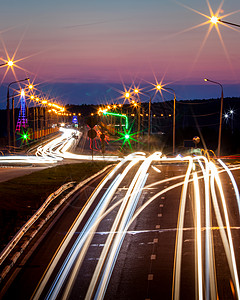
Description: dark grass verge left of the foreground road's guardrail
xmin=0 ymin=162 xmax=108 ymax=251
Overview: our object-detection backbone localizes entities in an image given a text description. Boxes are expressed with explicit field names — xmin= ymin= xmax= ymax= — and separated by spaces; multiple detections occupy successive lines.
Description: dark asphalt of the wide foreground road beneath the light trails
xmin=3 ymin=161 xmax=240 ymax=299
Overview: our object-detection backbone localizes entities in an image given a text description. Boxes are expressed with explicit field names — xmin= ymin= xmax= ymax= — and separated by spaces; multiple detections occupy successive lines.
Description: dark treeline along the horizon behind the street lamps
xmin=0 ymin=97 xmax=240 ymax=154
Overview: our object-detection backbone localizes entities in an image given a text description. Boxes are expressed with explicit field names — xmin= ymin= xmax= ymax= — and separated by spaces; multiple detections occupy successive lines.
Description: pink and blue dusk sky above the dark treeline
xmin=0 ymin=0 xmax=240 ymax=107
